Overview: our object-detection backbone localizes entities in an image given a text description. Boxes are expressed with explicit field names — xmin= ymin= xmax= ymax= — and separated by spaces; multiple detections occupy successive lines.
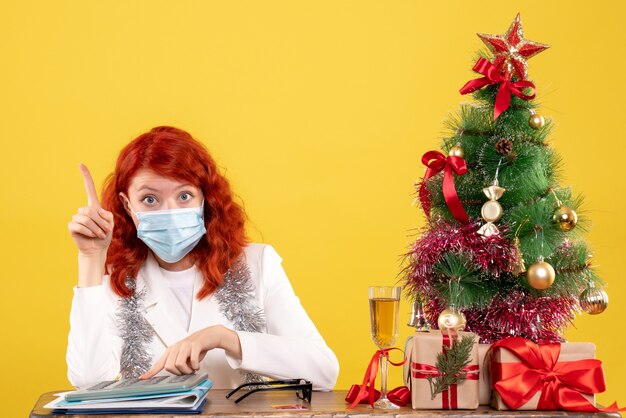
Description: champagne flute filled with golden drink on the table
xmin=368 ymin=286 xmax=402 ymax=409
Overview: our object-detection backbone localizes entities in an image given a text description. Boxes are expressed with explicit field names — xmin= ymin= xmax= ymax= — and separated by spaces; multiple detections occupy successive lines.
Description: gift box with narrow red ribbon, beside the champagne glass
xmin=411 ymin=330 xmax=479 ymax=409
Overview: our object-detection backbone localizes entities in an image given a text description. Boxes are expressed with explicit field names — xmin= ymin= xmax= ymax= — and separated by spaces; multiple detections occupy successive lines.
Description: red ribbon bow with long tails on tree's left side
xmin=419 ymin=151 xmax=469 ymax=224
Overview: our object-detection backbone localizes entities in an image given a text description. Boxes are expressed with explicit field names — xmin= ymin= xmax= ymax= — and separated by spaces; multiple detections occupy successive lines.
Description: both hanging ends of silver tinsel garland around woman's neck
xmin=117 ymin=254 xmax=266 ymax=383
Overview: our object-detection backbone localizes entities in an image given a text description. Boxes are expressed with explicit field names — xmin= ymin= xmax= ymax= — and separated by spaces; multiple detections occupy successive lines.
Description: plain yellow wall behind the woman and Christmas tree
xmin=0 ymin=0 xmax=626 ymax=416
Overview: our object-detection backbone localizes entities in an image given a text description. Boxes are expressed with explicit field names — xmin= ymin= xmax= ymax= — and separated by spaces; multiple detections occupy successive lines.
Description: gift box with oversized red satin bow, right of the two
xmin=487 ymin=337 xmax=619 ymax=412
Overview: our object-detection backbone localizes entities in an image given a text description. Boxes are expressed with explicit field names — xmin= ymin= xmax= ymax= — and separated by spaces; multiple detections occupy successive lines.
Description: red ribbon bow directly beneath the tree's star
xmin=460 ymin=58 xmax=535 ymax=120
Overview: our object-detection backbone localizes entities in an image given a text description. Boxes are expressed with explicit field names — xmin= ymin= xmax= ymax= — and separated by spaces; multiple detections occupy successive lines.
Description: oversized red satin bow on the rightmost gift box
xmin=487 ymin=337 xmax=624 ymax=412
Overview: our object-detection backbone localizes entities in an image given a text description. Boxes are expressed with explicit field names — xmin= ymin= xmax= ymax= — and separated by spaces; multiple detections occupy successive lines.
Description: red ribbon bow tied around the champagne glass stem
xmin=346 ymin=348 xmax=411 ymax=409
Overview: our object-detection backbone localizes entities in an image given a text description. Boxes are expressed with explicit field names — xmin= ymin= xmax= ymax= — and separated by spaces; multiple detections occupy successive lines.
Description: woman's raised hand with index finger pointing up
xmin=68 ymin=164 xmax=113 ymax=287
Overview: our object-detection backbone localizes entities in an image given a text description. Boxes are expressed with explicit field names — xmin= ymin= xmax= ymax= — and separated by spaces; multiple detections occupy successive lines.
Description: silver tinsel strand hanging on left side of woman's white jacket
xmin=117 ymin=279 xmax=154 ymax=379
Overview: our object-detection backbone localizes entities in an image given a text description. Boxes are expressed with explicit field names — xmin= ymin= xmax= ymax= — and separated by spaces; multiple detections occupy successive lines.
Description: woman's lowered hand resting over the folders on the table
xmin=139 ymin=325 xmax=241 ymax=379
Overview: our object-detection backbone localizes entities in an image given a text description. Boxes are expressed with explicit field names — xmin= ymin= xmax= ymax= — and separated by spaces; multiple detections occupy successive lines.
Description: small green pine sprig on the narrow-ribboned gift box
xmin=427 ymin=335 xmax=475 ymax=399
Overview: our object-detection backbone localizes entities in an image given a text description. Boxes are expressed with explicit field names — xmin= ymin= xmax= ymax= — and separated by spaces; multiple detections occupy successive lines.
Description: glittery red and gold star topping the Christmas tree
xmin=477 ymin=13 xmax=550 ymax=80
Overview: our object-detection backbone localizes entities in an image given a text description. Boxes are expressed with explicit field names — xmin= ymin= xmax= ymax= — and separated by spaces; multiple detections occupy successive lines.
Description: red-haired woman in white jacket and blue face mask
xmin=67 ymin=127 xmax=339 ymax=390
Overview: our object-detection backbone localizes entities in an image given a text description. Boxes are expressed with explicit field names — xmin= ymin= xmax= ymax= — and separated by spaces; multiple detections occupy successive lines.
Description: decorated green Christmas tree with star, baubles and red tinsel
xmin=405 ymin=15 xmax=608 ymax=343
